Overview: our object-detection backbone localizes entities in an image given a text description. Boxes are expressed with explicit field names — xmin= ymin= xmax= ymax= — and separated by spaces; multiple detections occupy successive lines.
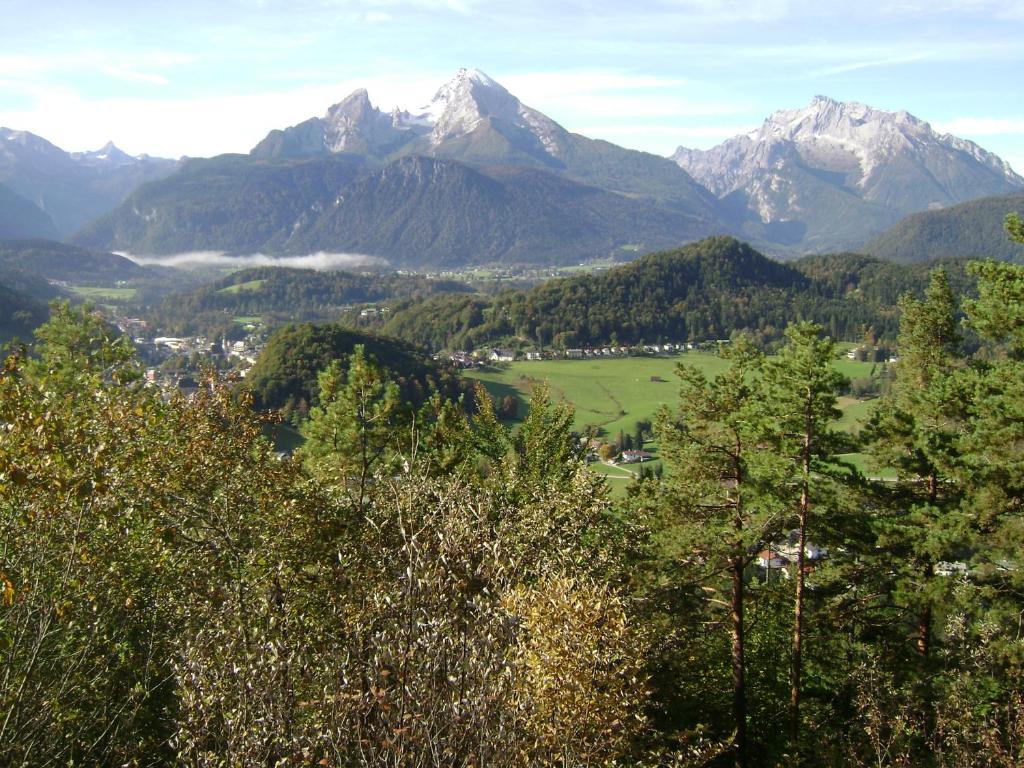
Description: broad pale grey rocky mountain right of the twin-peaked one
xmin=673 ymin=96 xmax=1024 ymax=253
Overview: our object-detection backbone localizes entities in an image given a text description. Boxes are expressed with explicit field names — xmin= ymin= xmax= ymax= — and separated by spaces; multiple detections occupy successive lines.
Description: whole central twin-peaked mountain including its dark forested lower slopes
xmin=76 ymin=70 xmax=725 ymax=268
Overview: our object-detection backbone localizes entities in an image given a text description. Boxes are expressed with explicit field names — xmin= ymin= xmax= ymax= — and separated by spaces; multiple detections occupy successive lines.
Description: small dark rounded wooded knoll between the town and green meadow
xmin=244 ymin=323 xmax=462 ymax=410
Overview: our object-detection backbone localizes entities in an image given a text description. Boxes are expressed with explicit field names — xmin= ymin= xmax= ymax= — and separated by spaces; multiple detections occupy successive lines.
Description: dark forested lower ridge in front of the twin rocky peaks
xmin=74 ymin=154 xmax=714 ymax=268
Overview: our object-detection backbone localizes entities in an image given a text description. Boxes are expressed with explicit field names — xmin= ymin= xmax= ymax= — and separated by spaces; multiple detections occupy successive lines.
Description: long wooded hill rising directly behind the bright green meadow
xmin=383 ymin=238 xmax=971 ymax=349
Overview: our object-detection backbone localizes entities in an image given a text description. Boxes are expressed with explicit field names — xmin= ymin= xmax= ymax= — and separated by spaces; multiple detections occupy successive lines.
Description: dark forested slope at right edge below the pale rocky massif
xmin=860 ymin=193 xmax=1024 ymax=263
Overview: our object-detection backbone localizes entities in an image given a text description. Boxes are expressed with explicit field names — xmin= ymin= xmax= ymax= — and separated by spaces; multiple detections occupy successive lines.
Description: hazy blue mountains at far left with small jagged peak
xmin=0 ymin=128 xmax=178 ymax=238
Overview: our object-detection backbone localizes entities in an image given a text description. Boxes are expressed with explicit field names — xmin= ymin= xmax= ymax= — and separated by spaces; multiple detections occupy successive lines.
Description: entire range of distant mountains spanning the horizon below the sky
xmin=8 ymin=70 xmax=1024 ymax=268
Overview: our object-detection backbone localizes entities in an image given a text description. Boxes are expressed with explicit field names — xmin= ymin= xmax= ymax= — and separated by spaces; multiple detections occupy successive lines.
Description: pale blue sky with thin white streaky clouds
xmin=0 ymin=0 xmax=1024 ymax=173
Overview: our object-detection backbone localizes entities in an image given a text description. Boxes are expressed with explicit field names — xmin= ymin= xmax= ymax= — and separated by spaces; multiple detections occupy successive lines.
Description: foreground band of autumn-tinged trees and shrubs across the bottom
xmin=0 ymin=222 xmax=1024 ymax=768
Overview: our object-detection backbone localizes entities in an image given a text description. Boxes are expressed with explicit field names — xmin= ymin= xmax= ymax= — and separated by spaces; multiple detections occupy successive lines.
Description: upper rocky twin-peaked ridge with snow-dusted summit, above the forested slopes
xmin=250 ymin=69 xmax=721 ymax=218
